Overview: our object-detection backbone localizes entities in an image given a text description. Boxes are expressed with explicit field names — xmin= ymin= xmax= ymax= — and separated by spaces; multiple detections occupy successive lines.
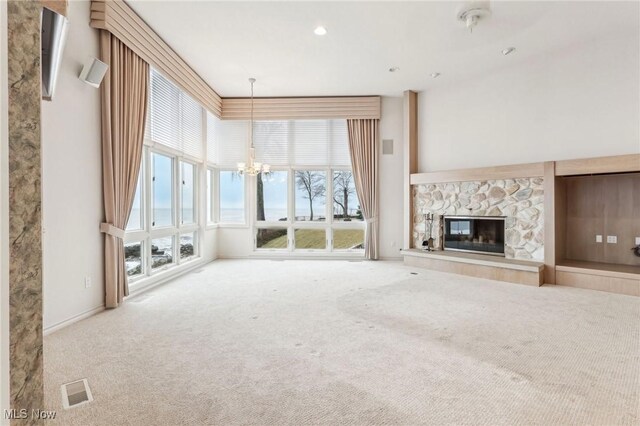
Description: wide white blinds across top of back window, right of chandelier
xmin=254 ymin=120 xmax=351 ymax=166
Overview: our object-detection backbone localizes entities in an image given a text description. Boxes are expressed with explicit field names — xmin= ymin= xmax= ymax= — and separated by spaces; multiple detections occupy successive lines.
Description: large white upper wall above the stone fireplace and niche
xmin=418 ymin=31 xmax=640 ymax=172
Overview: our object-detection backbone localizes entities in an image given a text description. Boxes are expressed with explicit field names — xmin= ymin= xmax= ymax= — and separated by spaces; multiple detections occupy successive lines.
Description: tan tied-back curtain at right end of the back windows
xmin=347 ymin=119 xmax=380 ymax=259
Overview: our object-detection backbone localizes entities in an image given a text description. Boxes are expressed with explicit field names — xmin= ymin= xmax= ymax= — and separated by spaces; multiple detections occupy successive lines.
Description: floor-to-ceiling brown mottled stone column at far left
xmin=7 ymin=0 xmax=45 ymax=424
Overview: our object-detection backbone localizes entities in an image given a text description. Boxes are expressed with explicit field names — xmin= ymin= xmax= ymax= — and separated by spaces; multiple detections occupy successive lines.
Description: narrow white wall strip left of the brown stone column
xmin=0 ymin=2 xmax=9 ymax=425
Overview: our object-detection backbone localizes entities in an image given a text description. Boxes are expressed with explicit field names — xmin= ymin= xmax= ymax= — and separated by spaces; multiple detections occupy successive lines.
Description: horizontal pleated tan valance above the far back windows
xmin=222 ymin=96 xmax=380 ymax=120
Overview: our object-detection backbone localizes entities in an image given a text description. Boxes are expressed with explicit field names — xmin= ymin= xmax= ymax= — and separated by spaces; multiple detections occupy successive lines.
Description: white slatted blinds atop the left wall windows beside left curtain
xmin=146 ymin=68 xmax=203 ymax=158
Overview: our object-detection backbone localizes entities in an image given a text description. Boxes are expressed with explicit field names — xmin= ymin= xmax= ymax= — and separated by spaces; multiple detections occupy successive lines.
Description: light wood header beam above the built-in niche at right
xmin=556 ymin=154 xmax=640 ymax=176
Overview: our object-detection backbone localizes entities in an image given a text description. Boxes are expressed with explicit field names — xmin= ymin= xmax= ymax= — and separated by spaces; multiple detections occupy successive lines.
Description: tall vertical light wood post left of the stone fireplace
xmin=402 ymin=90 xmax=418 ymax=248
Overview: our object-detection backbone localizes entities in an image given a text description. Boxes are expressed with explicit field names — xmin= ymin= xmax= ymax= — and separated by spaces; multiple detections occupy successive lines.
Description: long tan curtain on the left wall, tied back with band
xmin=100 ymin=31 xmax=149 ymax=308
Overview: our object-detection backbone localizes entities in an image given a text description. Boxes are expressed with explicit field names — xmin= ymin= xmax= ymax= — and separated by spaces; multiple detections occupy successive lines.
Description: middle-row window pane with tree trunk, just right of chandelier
xmin=256 ymin=171 xmax=288 ymax=222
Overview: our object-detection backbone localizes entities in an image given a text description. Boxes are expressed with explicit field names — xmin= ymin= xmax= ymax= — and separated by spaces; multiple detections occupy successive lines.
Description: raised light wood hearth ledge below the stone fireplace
xmin=402 ymin=249 xmax=544 ymax=286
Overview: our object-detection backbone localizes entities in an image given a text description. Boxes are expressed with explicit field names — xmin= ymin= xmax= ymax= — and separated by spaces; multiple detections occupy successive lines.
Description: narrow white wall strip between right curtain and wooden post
xmin=379 ymin=96 xmax=404 ymax=259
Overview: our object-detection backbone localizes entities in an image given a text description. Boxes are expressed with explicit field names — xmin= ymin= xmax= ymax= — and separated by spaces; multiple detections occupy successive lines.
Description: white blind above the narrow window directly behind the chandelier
xmin=207 ymin=112 xmax=249 ymax=168
